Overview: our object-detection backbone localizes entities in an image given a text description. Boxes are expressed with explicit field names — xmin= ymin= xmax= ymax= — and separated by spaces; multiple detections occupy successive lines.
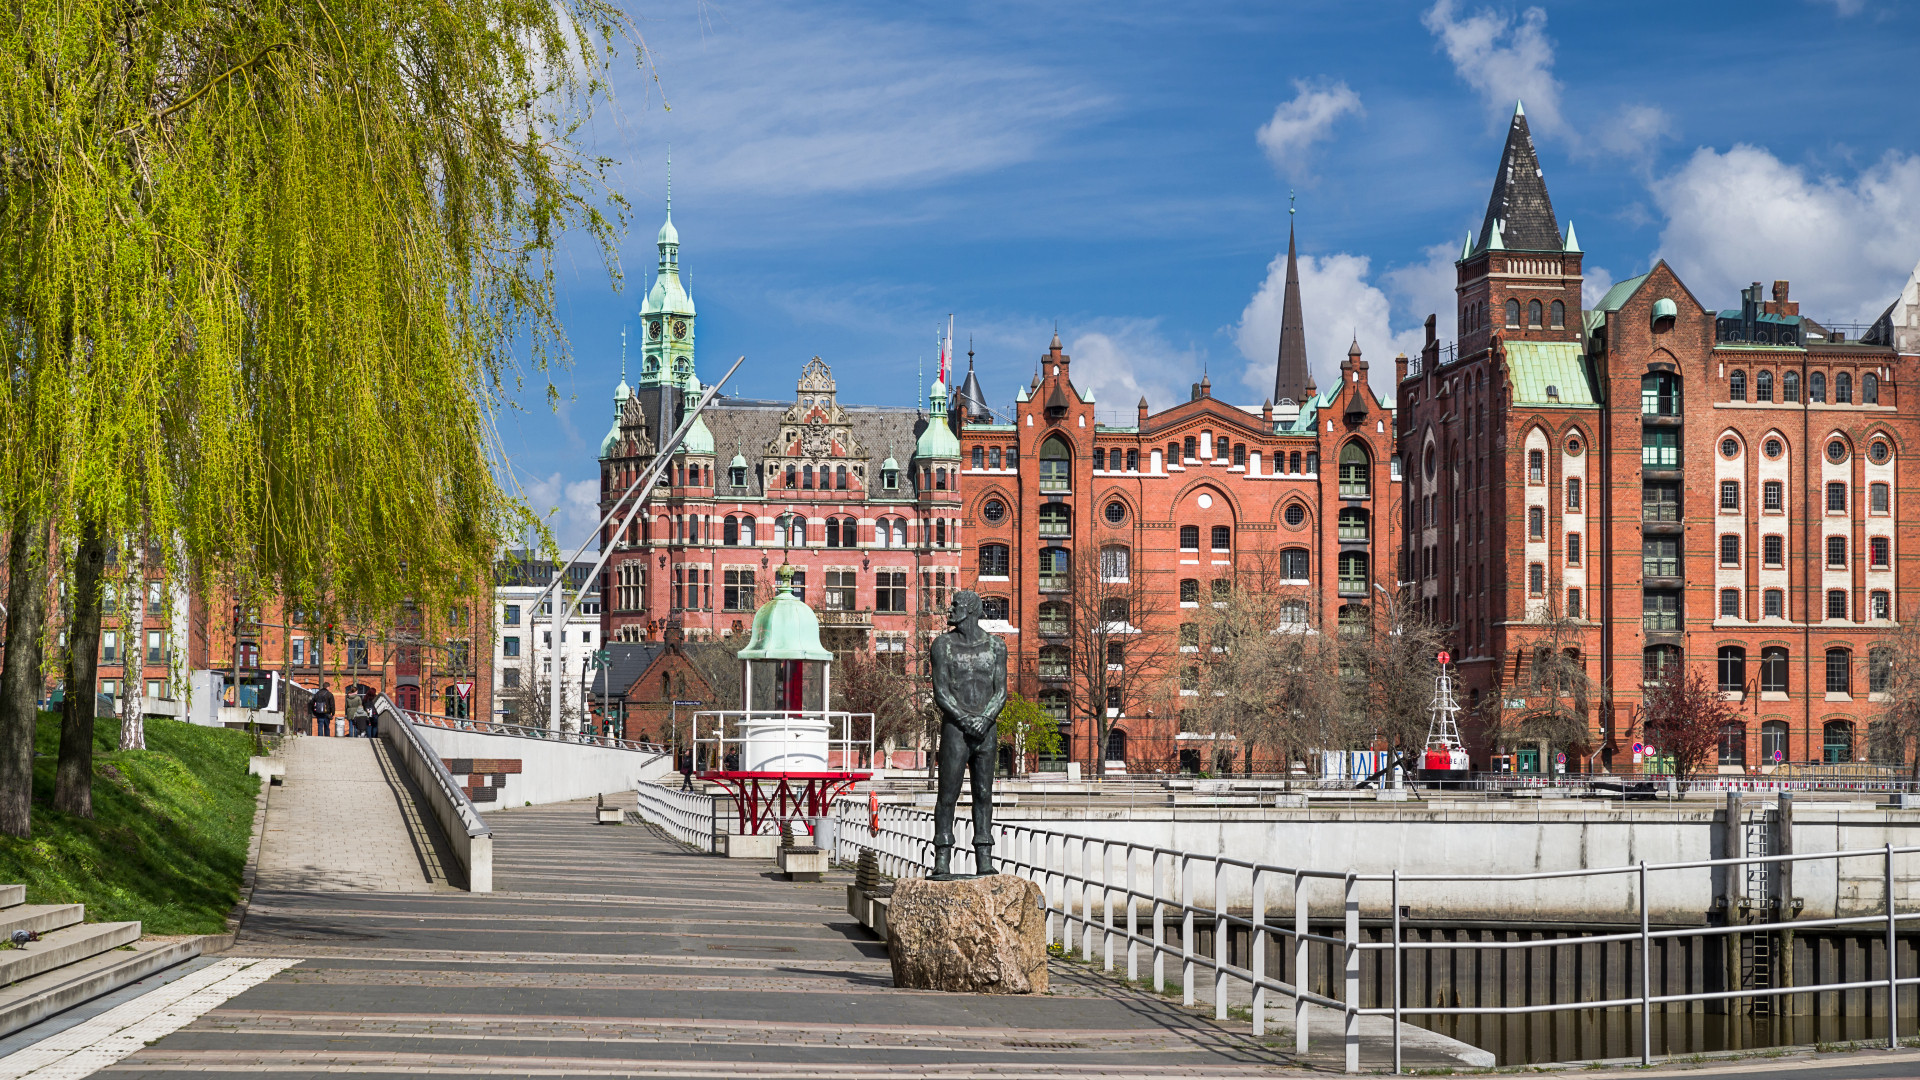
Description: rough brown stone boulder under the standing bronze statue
xmin=887 ymin=874 xmax=1046 ymax=994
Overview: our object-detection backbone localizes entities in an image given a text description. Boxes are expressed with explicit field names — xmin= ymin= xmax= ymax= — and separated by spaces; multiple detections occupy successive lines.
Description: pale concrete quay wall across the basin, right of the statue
xmin=995 ymin=799 xmax=1920 ymax=926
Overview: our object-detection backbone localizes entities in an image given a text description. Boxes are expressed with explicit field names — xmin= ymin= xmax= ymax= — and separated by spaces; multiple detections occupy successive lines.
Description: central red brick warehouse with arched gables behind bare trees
xmin=960 ymin=272 xmax=1405 ymax=771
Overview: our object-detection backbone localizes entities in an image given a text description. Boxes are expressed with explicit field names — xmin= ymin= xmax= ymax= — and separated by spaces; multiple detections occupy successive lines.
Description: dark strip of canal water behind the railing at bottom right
xmin=1407 ymin=1009 xmax=1920 ymax=1065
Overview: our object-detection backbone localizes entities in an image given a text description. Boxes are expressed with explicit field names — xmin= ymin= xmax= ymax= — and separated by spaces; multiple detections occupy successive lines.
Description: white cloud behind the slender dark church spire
xmin=1233 ymin=252 xmax=1453 ymax=400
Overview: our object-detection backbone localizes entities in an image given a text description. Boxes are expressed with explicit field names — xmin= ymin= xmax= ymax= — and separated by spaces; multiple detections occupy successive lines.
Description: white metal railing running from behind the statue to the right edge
xmin=833 ymin=799 xmax=1920 ymax=1072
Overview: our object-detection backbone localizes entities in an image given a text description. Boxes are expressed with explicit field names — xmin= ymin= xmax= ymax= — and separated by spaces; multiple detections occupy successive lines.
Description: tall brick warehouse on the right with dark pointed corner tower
xmin=1398 ymin=100 xmax=1920 ymax=771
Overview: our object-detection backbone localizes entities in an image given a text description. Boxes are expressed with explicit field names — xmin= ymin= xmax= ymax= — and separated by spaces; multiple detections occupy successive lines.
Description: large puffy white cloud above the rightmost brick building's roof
xmin=1651 ymin=144 xmax=1920 ymax=323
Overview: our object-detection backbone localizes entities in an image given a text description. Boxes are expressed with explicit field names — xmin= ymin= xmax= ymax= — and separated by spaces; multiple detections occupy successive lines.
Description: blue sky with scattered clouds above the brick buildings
xmin=501 ymin=0 xmax=1920 ymax=540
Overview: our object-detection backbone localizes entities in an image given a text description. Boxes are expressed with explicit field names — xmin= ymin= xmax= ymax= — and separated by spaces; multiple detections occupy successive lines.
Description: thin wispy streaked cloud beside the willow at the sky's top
xmin=618 ymin=4 xmax=1102 ymax=202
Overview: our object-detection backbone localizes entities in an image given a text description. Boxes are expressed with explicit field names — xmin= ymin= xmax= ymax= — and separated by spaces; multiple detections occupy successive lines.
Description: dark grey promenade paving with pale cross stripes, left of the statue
xmin=102 ymin=791 xmax=1359 ymax=1080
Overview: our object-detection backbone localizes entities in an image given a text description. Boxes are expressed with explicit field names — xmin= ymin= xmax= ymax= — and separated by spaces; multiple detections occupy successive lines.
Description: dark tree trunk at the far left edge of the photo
xmin=0 ymin=513 xmax=50 ymax=838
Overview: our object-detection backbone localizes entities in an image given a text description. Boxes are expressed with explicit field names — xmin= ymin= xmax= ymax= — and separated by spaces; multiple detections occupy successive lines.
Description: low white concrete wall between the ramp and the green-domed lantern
xmin=413 ymin=724 xmax=674 ymax=811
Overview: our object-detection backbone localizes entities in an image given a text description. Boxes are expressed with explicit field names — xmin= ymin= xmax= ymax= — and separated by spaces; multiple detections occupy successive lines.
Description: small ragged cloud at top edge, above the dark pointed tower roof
xmin=1421 ymin=0 xmax=1563 ymax=135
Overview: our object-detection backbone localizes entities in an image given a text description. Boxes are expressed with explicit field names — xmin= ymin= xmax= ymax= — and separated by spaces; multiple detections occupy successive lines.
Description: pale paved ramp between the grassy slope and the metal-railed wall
xmin=257 ymin=738 xmax=445 ymax=894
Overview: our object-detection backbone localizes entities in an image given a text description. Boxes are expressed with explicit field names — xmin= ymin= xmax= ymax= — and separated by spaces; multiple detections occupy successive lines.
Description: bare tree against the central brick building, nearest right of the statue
xmin=1039 ymin=546 xmax=1179 ymax=776
